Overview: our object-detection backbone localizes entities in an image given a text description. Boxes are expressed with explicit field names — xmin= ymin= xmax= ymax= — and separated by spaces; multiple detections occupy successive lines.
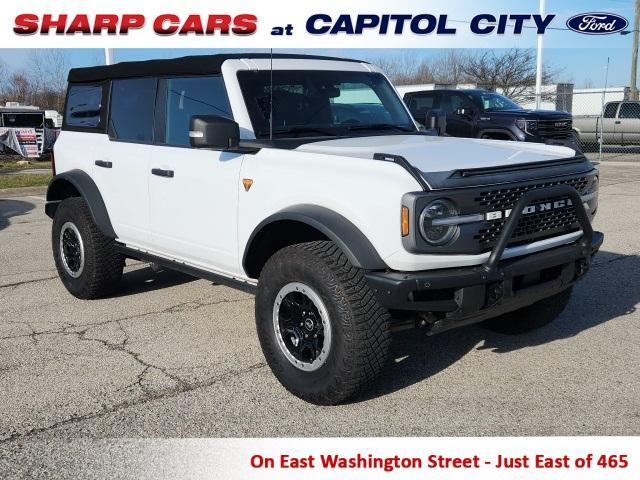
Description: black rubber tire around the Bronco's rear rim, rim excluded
xmin=51 ymin=197 xmax=124 ymax=300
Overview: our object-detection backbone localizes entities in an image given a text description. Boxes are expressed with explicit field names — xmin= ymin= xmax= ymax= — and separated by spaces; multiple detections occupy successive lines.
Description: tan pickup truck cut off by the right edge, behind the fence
xmin=573 ymin=101 xmax=640 ymax=150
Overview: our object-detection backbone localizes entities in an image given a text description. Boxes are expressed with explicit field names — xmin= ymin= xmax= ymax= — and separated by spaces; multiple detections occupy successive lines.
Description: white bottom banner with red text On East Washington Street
xmin=57 ymin=437 xmax=640 ymax=480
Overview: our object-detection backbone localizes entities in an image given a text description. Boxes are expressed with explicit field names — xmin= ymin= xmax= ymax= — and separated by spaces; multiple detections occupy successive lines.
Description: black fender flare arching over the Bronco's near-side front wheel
xmin=242 ymin=205 xmax=389 ymax=272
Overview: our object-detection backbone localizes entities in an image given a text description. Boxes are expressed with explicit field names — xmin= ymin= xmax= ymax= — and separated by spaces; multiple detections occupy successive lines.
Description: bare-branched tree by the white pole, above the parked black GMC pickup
xmin=462 ymin=48 xmax=556 ymax=101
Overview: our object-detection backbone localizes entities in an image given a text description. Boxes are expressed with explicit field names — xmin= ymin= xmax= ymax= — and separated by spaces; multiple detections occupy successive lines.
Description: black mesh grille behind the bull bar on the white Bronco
xmin=474 ymin=176 xmax=590 ymax=252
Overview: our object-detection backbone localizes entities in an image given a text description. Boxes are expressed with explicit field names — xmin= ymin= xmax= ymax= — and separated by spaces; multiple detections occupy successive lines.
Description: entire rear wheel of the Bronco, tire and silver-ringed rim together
xmin=51 ymin=197 xmax=124 ymax=299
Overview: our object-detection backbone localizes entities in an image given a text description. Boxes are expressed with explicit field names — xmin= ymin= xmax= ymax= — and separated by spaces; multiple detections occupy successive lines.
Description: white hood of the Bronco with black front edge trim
xmin=296 ymin=135 xmax=593 ymax=189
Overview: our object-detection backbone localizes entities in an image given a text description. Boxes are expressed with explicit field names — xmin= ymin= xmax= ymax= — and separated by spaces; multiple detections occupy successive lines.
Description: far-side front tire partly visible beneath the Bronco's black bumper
xmin=481 ymin=287 xmax=573 ymax=335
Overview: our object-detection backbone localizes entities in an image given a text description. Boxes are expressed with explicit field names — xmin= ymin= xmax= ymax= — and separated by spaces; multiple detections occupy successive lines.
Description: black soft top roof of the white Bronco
xmin=68 ymin=53 xmax=366 ymax=83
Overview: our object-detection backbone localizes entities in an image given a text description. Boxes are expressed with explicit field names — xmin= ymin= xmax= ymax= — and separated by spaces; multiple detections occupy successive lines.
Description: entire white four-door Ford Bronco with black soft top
xmin=46 ymin=53 xmax=603 ymax=404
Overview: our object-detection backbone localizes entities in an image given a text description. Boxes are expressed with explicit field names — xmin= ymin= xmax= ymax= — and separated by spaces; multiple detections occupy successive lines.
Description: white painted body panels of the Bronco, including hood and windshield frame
xmin=55 ymin=59 xmax=580 ymax=283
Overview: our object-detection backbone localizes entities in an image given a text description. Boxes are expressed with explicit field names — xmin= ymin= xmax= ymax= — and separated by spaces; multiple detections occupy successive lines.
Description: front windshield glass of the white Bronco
xmin=238 ymin=70 xmax=417 ymax=138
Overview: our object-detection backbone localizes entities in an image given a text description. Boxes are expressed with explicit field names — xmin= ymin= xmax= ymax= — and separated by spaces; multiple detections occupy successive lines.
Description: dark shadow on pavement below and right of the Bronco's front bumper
xmin=354 ymin=252 xmax=640 ymax=402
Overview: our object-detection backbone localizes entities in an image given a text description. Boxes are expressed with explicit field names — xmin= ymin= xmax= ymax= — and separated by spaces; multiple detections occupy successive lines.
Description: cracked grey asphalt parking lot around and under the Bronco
xmin=0 ymin=162 xmax=640 ymax=477
